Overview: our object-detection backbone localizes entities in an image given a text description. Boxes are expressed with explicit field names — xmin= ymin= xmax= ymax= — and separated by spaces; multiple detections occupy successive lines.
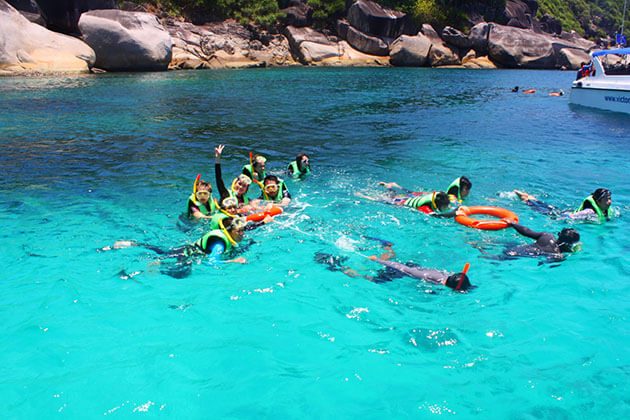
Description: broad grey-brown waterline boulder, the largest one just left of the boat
xmin=488 ymin=24 xmax=556 ymax=69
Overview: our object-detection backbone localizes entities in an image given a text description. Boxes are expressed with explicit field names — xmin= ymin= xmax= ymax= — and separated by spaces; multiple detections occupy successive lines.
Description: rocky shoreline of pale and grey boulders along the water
xmin=0 ymin=0 xmax=596 ymax=75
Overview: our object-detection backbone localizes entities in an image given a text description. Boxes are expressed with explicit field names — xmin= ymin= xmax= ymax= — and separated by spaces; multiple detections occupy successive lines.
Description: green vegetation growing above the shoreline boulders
xmin=121 ymin=0 xmax=629 ymax=38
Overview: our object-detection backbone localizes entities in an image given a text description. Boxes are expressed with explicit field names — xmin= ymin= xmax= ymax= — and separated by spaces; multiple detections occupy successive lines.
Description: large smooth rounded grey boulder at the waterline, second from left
xmin=79 ymin=10 xmax=172 ymax=71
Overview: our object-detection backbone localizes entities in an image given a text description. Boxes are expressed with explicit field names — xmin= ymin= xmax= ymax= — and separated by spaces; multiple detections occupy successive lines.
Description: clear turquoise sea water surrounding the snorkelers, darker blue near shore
xmin=0 ymin=69 xmax=630 ymax=419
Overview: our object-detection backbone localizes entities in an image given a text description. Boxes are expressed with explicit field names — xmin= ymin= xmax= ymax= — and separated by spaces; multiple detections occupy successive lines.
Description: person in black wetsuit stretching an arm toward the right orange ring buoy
xmin=499 ymin=221 xmax=580 ymax=260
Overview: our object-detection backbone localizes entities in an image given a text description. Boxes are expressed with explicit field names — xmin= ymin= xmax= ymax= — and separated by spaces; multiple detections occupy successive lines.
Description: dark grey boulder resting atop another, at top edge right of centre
xmin=347 ymin=0 xmax=411 ymax=39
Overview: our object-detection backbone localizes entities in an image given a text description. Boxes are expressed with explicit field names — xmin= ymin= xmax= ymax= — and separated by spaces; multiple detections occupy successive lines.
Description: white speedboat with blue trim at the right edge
xmin=571 ymin=48 xmax=630 ymax=114
